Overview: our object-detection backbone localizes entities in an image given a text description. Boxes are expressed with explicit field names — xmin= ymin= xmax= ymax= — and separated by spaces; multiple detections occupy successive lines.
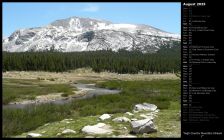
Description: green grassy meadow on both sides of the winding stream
xmin=3 ymin=76 xmax=180 ymax=137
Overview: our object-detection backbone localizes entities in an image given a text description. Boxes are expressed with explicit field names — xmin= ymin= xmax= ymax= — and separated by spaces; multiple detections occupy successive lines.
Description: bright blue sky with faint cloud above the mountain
xmin=3 ymin=2 xmax=181 ymax=36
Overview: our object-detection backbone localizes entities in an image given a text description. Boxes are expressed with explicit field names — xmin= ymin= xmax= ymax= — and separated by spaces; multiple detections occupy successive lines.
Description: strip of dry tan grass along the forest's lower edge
xmin=3 ymin=69 xmax=179 ymax=83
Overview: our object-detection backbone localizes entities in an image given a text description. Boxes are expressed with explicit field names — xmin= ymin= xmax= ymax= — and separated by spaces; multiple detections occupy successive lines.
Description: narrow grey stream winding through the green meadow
xmin=3 ymin=83 xmax=121 ymax=108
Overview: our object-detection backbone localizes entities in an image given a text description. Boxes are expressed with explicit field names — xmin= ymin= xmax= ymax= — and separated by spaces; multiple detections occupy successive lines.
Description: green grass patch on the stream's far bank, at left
xmin=3 ymin=79 xmax=76 ymax=104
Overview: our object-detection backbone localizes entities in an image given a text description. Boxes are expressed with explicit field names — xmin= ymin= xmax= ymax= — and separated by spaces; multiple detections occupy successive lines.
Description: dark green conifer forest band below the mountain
xmin=3 ymin=47 xmax=180 ymax=73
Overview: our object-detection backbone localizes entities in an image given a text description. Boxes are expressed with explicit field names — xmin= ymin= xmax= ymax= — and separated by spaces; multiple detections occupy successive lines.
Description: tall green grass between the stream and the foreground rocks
xmin=3 ymin=80 xmax=180 ymax=137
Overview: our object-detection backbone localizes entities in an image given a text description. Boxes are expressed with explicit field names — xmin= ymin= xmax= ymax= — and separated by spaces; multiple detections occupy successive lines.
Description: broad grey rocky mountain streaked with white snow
xmin=2 ymin=17 xmax=180 ymax=52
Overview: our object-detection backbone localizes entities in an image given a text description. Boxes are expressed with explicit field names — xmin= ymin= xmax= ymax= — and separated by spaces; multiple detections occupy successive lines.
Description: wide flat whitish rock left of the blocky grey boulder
xmin=82 ymin=123 xmax=112 ymax=135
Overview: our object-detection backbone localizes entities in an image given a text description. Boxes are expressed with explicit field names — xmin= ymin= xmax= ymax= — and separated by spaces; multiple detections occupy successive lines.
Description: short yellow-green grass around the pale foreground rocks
xmin=16 ymin=110 xmax=181 ymax=138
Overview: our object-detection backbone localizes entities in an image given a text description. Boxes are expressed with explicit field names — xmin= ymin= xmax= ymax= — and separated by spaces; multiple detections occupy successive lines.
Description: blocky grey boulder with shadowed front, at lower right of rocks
xmin=131 ymin=119 xmax=157 ymax=134
